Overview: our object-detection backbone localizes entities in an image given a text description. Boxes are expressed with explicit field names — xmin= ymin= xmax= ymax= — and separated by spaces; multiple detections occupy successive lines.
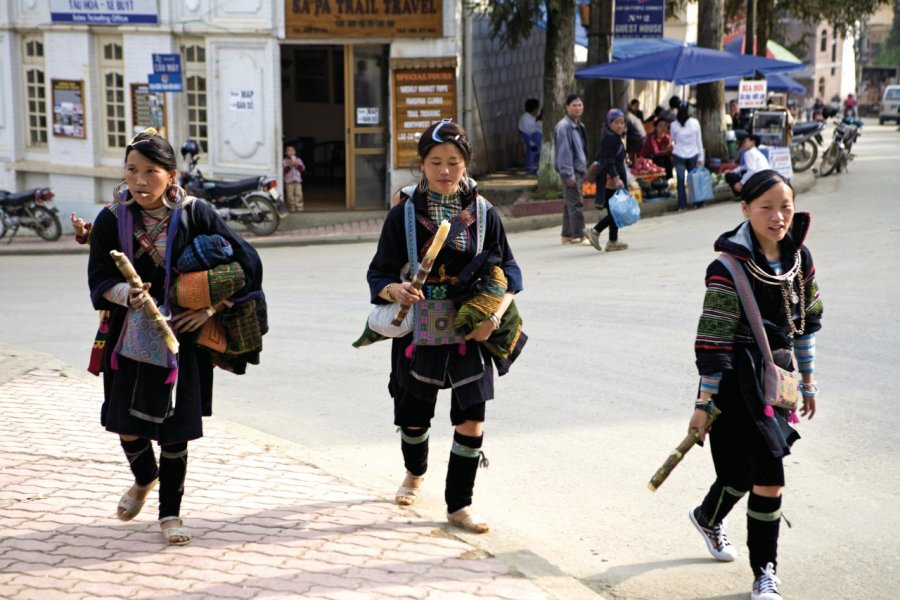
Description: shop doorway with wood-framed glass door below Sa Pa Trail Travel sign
xmin=281 ymin=44 xmax=388 ymax=211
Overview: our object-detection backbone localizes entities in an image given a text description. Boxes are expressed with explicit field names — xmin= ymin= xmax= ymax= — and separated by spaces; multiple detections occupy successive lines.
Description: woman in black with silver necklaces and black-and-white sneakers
xmin=688 ymin=170 xmax=822 ymax=600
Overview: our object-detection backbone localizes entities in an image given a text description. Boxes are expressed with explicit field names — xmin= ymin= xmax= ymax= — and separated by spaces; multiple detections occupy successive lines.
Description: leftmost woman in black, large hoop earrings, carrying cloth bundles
xmin=88 ymin=129 xmax=267 ymax=545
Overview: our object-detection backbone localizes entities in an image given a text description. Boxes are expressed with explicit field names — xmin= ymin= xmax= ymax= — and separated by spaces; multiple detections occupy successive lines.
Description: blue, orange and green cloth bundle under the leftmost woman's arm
xmin=169 ymin=234 xmax=262 ymax=370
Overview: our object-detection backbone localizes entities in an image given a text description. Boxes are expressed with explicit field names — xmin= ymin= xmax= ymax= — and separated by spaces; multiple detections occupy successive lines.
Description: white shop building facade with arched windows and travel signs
xmin=0 ymin=0 xmax=543 ymax=224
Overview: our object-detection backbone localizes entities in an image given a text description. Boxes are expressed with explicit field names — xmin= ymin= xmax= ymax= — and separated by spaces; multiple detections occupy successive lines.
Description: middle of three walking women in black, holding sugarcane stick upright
xmin=366 ymin=119 xmax=526 ymax=533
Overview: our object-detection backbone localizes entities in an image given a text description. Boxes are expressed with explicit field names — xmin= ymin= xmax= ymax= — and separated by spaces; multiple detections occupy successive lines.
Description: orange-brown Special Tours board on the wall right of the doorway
xmin=393 ymin=67 xmax=456 ymax=169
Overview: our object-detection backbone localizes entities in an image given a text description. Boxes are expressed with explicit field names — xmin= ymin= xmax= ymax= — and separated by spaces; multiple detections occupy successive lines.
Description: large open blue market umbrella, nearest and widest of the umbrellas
xmin=575 ymin=46 xmax=803 ymax=85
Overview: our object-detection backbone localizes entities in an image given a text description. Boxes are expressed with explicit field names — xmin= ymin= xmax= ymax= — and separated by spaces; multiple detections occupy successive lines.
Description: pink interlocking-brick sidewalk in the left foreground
xmin=0 ymin=346 xmax=597 ymax=600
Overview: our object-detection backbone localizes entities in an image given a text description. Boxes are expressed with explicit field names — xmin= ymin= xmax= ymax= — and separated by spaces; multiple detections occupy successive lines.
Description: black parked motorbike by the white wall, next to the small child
xmin=179 ymin=140 xmax=288 ymax=235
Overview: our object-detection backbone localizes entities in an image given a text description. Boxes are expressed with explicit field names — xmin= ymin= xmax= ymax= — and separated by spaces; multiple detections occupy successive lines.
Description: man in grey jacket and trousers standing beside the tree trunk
xmin=553 ymin=94 xmax=587 ymax=244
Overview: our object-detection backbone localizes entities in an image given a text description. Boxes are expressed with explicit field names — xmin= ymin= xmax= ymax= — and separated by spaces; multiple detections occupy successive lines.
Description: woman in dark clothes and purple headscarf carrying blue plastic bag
xmin=584 ymin=108 xmax=628 ymax=252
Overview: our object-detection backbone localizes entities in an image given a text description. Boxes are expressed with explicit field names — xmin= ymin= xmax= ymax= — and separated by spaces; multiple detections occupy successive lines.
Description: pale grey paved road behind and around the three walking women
xmin=0 ymin=126 xmax=900 ymax=599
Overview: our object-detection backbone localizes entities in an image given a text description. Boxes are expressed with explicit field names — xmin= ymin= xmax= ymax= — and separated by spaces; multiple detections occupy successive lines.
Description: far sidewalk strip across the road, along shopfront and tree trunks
xmin=0 ymin=171 xmax=816 ymax=257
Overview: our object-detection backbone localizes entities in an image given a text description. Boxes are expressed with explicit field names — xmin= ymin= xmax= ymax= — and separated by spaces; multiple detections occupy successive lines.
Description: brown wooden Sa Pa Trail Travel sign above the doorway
xmin=284 ymin=0 xmax=443 ymax=38
